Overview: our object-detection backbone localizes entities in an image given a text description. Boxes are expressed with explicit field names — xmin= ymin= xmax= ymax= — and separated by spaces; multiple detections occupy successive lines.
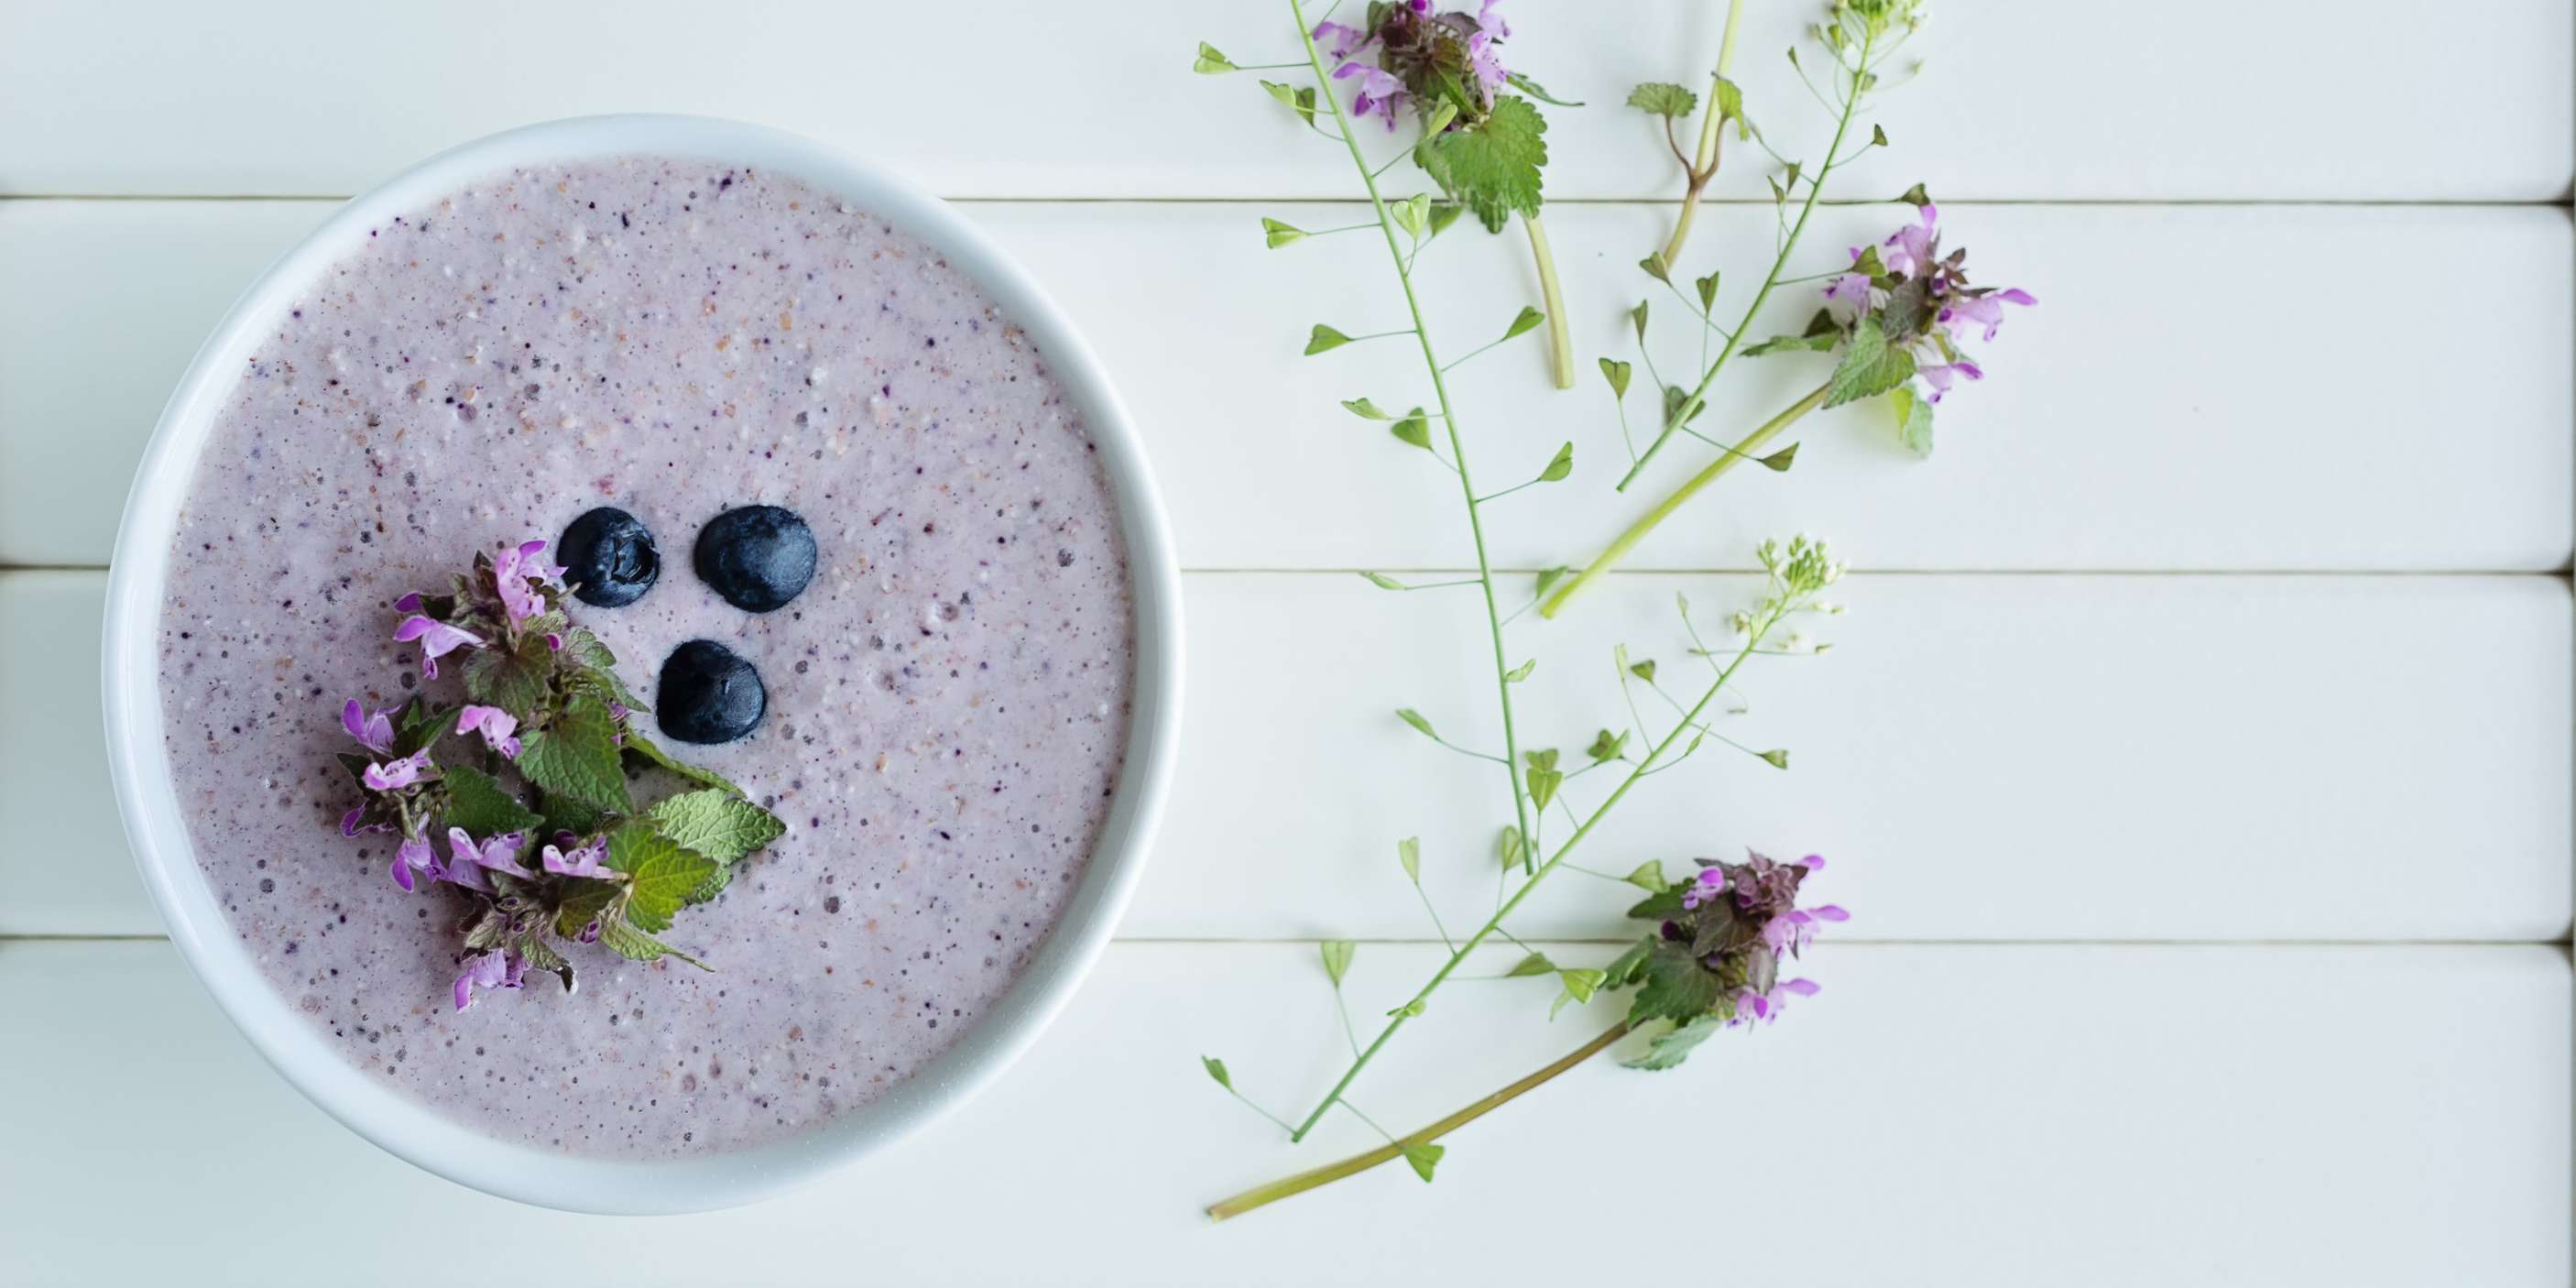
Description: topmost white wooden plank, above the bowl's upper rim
xmin=0 ymin=0 xmax=2571 ymax=201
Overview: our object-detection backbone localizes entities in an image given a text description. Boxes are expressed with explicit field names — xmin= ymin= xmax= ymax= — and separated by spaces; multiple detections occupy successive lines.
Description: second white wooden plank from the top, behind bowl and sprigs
xmin=0 ymin=201 xmax=2576 ymax=572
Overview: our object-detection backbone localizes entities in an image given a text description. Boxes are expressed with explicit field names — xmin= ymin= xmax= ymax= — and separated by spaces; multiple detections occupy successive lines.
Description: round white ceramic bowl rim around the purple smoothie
xmin=103 ymin=116 xmax=1180 ymax=1213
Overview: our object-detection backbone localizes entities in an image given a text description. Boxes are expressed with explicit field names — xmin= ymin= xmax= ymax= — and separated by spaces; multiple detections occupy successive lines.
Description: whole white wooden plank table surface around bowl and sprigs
xmin=0 ymin=0 xmax=2576 ymax=1285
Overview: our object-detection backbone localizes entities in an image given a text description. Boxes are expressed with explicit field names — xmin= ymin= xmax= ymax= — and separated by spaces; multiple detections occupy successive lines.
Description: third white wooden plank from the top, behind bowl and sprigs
xmin=15 ymin=574 xmax=2576 ymax=940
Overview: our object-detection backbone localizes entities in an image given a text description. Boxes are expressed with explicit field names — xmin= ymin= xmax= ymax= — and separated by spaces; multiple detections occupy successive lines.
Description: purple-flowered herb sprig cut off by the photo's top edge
xmin=1195 ymin=0 xmax=1582 ymax=389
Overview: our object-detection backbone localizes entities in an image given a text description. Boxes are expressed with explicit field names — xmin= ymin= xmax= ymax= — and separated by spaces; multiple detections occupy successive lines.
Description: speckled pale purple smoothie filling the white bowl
xmin=159 ymin=158 xmax=1133 ymax=1157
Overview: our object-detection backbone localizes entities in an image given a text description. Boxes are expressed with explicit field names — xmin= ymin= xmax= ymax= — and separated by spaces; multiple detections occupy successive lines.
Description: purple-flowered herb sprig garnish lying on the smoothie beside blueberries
xmin=340 ymin=541 xmax=786 ymax=1010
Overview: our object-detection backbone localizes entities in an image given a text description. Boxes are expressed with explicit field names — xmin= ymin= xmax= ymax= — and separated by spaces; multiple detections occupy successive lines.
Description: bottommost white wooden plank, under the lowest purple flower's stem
xmin=0 ymin=943 xmax=2571 ymax=1288
